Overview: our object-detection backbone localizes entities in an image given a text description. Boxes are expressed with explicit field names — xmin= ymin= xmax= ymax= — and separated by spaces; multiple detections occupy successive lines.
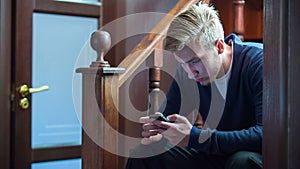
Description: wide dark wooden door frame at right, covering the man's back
xmin=263 ymin=0 xmax=300 ymax=169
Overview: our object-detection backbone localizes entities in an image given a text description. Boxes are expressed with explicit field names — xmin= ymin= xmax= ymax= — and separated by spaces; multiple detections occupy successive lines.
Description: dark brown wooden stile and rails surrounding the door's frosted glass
xmin=10 ymin=0 xmax=102 ymax=169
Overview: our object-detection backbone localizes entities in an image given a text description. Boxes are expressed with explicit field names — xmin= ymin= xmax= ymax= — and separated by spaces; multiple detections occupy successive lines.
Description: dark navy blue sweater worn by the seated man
xmin=164 ymin=34 xmax=263 ymax=155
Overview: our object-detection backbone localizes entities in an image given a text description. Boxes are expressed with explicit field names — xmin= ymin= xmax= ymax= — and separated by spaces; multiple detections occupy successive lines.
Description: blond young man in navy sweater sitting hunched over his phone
xmin=127 ymin=3 xmax=263 ymax=169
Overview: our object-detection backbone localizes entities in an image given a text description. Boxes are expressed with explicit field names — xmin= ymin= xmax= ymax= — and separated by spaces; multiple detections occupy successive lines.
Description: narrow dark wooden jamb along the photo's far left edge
xmin=0 ymin=0 xmax=12 ymax=169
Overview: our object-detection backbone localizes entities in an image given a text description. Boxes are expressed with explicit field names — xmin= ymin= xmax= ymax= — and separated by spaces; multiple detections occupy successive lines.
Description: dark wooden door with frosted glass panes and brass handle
xmin=11 ymin=0 xmax=101 ymax=169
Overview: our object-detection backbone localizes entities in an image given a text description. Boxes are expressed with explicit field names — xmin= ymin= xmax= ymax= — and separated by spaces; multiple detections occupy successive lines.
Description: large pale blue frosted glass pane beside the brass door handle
xmin=32 ymin=13 xmax=98 ymax=148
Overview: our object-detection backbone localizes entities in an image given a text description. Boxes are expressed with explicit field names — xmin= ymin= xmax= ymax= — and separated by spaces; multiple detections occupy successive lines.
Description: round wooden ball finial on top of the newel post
xmin=90 ymin=30 xmax=111 ymax=67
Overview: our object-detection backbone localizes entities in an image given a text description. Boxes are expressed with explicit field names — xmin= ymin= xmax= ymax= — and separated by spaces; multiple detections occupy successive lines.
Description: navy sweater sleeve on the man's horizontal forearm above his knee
xmin=188 ymin=125 xmax=262 ymax=154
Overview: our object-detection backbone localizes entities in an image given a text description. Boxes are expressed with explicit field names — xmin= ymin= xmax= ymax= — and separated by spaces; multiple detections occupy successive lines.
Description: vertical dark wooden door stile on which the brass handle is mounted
xmin=11 ymin=0 xmax=34 ymax=169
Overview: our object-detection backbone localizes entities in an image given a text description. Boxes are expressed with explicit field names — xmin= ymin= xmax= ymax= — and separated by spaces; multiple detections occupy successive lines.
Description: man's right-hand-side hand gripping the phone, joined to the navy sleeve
xmin=153 ymin=114 xmax=192 ymax=147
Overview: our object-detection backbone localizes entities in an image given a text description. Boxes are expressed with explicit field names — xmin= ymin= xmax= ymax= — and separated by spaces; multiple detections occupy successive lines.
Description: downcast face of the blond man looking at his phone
xmin=174 ymin=42 xmax=222 ymax=86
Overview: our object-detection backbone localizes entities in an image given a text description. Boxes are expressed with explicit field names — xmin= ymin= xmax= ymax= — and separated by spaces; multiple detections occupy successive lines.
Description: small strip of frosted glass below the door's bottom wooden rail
xmin=31 ymin=159 xmax=81 ymax=169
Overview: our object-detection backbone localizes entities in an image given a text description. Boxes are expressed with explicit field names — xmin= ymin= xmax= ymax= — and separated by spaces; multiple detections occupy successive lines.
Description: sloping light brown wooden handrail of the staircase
xmin=118 ymin=0 xmax=199 ymax=87
